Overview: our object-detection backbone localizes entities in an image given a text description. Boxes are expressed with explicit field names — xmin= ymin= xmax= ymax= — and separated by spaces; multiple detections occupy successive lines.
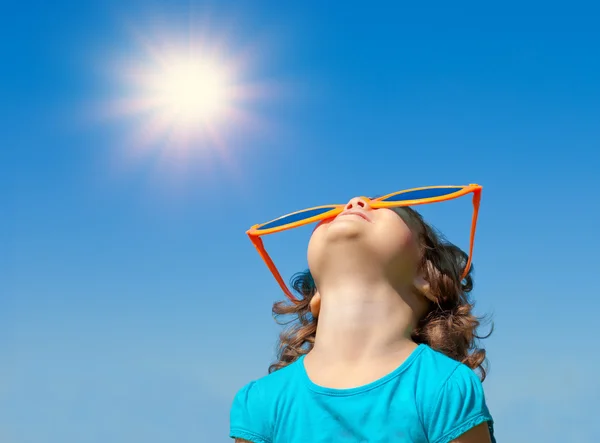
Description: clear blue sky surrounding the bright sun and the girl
xmin=0 ymin=1 xmax=600 ymax=443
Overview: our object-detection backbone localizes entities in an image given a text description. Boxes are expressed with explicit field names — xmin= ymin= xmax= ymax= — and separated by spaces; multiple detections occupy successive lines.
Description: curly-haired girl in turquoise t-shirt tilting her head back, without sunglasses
xmin=230 ymin=198 xmax=494 ymax=443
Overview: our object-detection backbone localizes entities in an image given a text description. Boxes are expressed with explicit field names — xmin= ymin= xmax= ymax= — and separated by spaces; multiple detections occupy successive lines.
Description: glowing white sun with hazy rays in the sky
xmin=101 ymin=26 xmax=269 ymax=165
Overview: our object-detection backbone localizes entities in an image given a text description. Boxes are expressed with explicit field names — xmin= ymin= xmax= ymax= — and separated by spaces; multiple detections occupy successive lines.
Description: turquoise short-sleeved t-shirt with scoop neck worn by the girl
xmin=230 ymin=345 xmax=494 ymax=443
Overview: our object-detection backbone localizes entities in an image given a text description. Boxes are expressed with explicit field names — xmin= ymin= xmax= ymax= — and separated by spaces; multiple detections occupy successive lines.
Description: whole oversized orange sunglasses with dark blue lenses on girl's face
xmin=246 ymin=184 xmax=482 ymax=302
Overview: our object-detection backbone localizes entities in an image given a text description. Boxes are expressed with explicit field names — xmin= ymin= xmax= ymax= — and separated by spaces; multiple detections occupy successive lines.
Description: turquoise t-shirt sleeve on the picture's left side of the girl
xmin=229 ymin=382 xmax=271 ymax=443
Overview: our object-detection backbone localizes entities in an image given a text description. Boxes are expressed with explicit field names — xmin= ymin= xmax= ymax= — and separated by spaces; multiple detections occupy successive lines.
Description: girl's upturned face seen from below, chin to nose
xmin=308 ymin=197 xmax=420 ymax=286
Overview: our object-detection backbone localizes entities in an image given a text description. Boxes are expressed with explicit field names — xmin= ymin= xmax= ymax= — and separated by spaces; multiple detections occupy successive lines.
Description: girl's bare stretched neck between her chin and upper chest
xmin=311 ymin=282 xmax=417 ymax=364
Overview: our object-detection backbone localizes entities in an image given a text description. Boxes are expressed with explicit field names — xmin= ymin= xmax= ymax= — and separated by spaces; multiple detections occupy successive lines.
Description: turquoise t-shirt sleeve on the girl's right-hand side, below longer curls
xmin=426 ymin=364 xmax=492 ymax=443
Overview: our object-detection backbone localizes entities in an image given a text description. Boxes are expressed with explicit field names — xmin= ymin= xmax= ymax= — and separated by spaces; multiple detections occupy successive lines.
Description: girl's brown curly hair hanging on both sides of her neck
xmin=269 ymin=207 xmax=492 ymax=381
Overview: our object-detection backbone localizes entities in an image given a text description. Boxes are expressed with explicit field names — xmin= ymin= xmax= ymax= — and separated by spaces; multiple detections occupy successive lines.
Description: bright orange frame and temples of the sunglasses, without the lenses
xmin=246 ymin=184 xmax=482 ymax=302
